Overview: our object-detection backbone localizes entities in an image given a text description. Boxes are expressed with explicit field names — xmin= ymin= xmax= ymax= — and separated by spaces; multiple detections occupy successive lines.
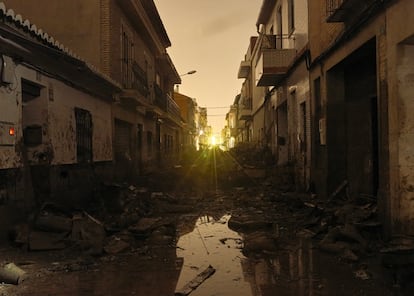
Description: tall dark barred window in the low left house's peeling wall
xmin=75 ymin=108 xmax=92 ymax=163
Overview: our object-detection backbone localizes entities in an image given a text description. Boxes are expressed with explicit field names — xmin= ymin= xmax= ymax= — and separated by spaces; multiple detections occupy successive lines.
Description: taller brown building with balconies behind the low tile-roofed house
xmin=5 ymin=0 xmax=182 ymax=181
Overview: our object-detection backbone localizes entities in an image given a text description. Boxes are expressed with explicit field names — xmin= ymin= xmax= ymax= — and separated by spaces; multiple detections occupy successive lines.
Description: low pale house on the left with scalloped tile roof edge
xmin=0 ymin=2 xmax=121 ymax=239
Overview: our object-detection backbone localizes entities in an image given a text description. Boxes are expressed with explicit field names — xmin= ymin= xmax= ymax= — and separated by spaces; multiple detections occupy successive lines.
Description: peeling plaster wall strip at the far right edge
xmin=384 ymin=0 xmax=414 ymax=235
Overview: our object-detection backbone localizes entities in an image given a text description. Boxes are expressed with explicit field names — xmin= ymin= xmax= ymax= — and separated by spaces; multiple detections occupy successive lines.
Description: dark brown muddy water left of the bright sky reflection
xmin=9 ymin=250 xmax=183 ymax=296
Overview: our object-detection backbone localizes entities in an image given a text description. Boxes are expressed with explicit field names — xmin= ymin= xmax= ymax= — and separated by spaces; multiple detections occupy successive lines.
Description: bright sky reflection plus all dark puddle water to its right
xmin=177 ymin=215 xmax=395 ymax=296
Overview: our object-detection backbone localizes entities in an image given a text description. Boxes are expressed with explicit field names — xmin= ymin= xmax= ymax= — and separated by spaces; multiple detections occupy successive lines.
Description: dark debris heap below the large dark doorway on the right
xmin=290 ymin=191 xmax=381 ymax=261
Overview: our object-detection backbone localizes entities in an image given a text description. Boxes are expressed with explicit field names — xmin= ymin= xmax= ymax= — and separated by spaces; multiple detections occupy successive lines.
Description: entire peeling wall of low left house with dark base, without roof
xmin=0 ymin=53 xmax=112 ymax=210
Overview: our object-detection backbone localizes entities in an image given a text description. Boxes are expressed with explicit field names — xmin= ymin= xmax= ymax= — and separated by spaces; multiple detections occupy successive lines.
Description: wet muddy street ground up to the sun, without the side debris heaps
xmin=0 ymin=151 xmax=413 ymax=296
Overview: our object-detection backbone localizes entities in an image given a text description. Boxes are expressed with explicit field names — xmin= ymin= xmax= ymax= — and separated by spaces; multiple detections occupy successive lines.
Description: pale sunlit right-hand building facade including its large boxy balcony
xmin=238 ymin=0 xmax=311 ymax=190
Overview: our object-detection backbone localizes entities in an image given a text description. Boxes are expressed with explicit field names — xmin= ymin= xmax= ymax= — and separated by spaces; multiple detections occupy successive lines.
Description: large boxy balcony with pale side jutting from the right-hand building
xmin=255 ymin=48 xmax=296 ymax=86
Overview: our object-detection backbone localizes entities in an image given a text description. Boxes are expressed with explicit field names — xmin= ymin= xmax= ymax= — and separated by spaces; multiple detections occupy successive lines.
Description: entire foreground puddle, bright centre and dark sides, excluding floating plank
xmin=0 ymin=215 xmax=402 ymax=296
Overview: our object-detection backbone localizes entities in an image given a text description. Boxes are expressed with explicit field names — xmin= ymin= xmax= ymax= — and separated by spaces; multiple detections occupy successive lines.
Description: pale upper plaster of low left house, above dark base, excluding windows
xmin=15 ymin=65 xmax=112 ymax=165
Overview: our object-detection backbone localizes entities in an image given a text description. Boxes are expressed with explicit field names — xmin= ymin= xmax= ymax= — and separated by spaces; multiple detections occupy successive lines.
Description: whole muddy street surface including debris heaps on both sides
xmin=0 ymin=149 xmax=414 ymax=296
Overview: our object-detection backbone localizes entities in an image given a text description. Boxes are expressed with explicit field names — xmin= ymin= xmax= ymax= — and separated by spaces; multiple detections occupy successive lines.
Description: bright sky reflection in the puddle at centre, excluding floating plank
xmin=177 ymin=215 xmax=252 ymax=296
